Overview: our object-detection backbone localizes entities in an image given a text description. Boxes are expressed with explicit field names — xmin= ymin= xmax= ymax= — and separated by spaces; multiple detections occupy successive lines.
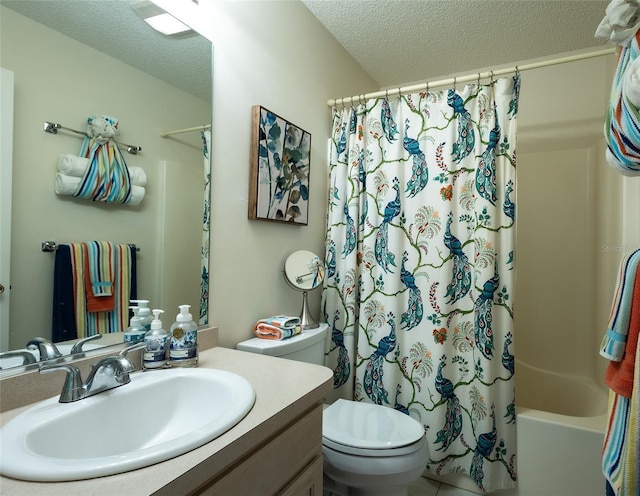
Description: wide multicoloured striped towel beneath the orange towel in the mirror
xmin=70 ymin=243 xmax=136 ymax=338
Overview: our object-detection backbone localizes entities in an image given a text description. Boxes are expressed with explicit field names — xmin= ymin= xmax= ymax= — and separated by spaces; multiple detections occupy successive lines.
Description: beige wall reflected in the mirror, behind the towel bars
xmin=0 ymin=7 xmax=211 ymax=348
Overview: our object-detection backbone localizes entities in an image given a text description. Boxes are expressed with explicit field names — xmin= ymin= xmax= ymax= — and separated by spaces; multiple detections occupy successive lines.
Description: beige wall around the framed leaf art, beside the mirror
xmin=192 ymin=1 xmax=377 ymax=347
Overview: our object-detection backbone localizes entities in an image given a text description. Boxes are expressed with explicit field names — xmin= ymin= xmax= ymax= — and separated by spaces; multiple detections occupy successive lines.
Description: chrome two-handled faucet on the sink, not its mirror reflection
xmin=40 ymin=343 xmax=145 ymax=403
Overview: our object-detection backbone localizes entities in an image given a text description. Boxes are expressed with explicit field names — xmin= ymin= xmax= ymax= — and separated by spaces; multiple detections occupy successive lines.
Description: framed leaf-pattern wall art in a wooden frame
xmin=249 ymin=105 xmax=311 ymax=225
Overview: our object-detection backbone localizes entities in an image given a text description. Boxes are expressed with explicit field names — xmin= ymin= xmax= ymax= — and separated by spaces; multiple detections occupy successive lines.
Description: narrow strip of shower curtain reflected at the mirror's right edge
xmin=198 ymin=131 xmax=211 ymax=324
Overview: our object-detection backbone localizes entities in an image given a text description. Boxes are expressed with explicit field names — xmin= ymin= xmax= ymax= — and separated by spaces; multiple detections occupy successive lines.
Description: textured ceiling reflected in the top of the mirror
xmin=0 ymin=0 xmax=211 ymax=101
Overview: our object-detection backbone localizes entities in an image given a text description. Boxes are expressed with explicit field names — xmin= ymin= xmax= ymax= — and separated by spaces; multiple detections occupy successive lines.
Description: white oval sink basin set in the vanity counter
xmin=0 ymin=368 xmax=255 ymax=481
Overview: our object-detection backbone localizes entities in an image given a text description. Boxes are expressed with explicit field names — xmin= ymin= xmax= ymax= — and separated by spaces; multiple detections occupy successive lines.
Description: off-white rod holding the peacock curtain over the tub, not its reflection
xmin=327 ymin=48 xmax=616 ymax=107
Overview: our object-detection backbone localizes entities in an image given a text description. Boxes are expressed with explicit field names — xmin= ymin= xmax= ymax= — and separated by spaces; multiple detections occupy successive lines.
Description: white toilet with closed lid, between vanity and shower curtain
xmin=236 ymin=324 xmax=428 ymax=496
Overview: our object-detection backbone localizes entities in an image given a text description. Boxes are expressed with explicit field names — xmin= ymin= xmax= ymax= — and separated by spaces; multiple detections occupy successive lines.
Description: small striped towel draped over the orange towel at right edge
xmin=600 ymin=249 xmax=640 ymax=362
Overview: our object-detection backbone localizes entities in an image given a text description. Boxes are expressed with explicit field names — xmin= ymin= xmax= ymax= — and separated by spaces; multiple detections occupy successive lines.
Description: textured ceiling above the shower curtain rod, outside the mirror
xmin=302 ymin=0 xmax=609 ymax=89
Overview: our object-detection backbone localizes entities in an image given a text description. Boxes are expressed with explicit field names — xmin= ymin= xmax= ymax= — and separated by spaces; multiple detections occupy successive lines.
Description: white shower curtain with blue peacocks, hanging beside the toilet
xmin=322 ymin=74 xmax=520 ymax=491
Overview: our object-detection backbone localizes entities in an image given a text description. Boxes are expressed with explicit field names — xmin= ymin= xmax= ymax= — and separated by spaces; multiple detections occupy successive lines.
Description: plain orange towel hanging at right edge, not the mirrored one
xmin=605 ymin=271 xmax=640 ymax=398
